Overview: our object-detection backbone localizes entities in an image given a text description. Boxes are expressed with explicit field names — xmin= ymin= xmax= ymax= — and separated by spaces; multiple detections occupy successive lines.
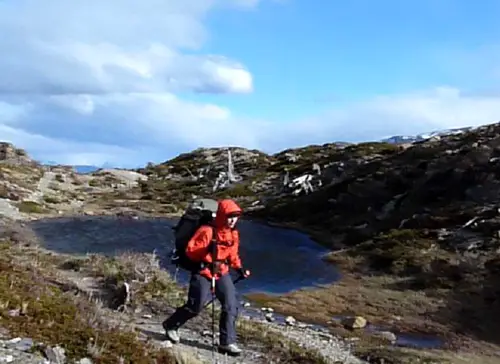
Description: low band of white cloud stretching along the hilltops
xmin=0 ymin=88 xmax=500 ymax=166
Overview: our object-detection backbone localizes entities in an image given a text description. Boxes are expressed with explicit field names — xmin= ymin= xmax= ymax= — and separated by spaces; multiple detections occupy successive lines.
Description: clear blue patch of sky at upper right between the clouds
xmin=200 ymin=0 xmax=500 ymax=120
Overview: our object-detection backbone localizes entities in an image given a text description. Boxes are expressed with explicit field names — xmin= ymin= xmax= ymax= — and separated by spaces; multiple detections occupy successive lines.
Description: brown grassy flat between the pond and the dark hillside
xmin=242 ymin=218 xmax=500 ymax=363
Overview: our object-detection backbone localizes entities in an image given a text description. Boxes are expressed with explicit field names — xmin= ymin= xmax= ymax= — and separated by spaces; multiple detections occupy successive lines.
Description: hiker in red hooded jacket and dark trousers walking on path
xmin=163 ymin=199 xmax=250 ymax=355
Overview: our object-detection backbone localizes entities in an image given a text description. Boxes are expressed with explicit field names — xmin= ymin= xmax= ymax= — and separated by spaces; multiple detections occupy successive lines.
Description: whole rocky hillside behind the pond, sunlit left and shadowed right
xmin=133 ymin=124 xmax=500 ymax=258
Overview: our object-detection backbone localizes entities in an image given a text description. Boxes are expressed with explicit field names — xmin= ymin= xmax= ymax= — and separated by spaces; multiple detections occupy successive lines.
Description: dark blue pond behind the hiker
xmin=30 ymin=216 xmax=339 ymax=294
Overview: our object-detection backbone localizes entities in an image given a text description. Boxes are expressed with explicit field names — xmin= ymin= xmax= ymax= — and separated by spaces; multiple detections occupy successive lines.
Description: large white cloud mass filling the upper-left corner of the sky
xmin=0 ymin=0 xmax=252 ymax=95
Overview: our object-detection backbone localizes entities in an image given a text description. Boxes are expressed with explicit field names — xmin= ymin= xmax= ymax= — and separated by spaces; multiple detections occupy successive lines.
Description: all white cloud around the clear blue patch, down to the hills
xmin=0 ymin=0 xmax=500 ymax=166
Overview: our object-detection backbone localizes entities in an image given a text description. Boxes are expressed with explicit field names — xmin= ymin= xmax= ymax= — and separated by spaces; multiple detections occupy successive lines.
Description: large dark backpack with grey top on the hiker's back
xmin=171 ymin=198 xmax=218 ymax=272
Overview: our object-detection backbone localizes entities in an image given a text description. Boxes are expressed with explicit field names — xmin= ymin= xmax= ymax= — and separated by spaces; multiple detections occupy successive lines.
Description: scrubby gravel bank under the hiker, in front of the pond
xmin=0 ymin=220 xmax=360 ymax=364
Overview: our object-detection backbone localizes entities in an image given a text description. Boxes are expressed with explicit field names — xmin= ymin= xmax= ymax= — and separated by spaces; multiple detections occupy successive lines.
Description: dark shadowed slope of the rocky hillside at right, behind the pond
xmin=262 ymin=120 xmax=500 ymax=249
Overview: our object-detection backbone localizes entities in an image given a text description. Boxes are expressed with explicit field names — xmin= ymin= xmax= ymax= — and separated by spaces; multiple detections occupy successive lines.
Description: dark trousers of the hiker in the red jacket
xmin=164 ymin=274 xmax=238 ymax=345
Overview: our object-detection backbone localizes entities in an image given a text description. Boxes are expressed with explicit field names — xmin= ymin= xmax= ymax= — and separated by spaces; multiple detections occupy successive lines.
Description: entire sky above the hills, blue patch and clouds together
xmin=0 ymin=0 xmax=500 ymax=167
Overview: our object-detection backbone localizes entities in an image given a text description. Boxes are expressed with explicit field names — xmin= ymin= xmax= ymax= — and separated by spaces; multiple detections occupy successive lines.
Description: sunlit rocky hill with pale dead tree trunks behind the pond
xmin=134 ymin=143 xmax=405 ymax=210
